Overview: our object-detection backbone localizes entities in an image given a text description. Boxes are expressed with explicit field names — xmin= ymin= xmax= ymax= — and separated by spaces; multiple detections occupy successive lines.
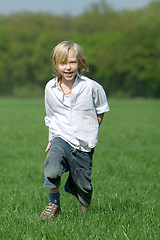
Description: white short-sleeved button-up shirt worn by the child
xmin=45 ymin=74 xmax=110 ymax=152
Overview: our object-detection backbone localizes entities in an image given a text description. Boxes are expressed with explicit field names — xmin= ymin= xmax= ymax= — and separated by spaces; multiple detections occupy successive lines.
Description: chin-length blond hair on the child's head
xmin=51 ymin=41 xmax=88 ymax=76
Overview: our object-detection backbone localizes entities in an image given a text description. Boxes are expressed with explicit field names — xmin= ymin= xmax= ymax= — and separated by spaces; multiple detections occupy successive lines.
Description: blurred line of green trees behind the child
xmin=0 ymin=1 xmax=160 ymax=97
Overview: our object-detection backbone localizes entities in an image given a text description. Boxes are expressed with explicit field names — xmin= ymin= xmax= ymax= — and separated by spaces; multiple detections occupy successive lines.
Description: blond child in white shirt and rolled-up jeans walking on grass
xmin=40 ymin=41 xmax=109 ymax=220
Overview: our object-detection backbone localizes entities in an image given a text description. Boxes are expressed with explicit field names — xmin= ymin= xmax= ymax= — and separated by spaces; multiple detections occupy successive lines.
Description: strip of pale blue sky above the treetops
xmin=0 ymin=0 xmax=152 ymax=16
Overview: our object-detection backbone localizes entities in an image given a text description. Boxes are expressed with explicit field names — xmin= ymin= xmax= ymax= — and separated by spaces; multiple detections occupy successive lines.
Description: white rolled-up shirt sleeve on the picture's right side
xmin=93 ymin=82 xmax=110 ymax=114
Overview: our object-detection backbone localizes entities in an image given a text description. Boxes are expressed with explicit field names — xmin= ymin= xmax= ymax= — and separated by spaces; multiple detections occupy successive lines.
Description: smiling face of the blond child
xmin=58 ymin=49 xmax=78 ymax=82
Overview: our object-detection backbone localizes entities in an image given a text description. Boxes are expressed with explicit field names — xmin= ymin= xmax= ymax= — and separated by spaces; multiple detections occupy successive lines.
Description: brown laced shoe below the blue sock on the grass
xmin=40 ymin=203 xmax=61 ymax=221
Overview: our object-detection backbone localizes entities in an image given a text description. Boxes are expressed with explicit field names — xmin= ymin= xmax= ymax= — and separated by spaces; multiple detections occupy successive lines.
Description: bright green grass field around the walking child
xmin=0 ymin=99 xmax=160 ymax=240
